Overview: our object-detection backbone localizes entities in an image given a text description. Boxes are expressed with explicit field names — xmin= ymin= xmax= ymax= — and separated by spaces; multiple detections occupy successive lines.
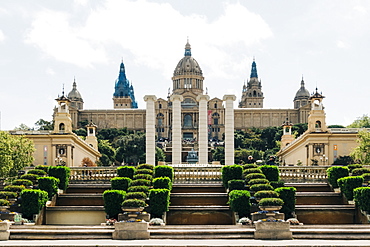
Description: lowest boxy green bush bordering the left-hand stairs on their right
xmin=103 ymin=190 xmax=126 ymax=219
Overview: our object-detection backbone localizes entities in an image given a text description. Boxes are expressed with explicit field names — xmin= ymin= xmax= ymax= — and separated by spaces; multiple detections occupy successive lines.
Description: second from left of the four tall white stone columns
xmin=170 ymin=94 xmax=184 ymax=164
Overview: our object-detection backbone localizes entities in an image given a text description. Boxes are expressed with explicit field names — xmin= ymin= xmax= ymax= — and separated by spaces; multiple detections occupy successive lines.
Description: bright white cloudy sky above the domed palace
xmin=0 ymin=0 xmax=370 ymax=130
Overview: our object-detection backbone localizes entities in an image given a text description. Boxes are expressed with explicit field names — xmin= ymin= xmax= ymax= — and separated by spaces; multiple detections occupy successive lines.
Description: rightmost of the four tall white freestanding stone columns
xmin=223 ymin=94 xmax=236 ymax=165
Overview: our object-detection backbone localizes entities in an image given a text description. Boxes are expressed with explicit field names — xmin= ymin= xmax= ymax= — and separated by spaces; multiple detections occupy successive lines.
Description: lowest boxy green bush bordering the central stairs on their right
xmin=228 ymin=190 xmax=251 ymax=218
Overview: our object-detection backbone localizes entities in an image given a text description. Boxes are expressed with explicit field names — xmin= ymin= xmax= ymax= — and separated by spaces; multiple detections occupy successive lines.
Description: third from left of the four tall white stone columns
xmin=197 ymin=95 xmax=209 ymax=164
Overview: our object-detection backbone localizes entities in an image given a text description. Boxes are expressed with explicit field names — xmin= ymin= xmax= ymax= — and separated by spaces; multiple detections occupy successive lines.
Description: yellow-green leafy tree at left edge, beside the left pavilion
xmin=0 ymin=131 xmax=35 ymax=178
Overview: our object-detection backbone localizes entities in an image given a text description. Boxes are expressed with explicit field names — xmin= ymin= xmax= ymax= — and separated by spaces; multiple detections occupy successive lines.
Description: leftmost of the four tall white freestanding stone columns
xmin=144 ymin=95 xmax=157 ymax=165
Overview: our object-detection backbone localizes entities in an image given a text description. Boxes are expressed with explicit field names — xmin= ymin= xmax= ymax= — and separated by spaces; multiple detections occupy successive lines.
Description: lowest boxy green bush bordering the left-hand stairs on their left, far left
xmin=21 ymin=189 xmax=48 ymax=219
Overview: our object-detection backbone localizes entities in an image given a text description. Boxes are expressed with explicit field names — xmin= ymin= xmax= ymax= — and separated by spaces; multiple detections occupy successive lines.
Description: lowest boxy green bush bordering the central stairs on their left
xmin=149 ymin=189 xmax=170 ymax=218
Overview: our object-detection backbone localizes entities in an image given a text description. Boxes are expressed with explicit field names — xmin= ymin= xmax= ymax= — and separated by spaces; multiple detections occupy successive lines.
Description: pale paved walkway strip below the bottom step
xmin=0 ymin=239 xmax=370 ymax=247
